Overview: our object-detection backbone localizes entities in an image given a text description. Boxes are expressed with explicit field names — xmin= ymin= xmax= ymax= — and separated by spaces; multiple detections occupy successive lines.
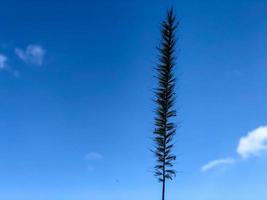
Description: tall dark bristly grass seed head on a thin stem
xmin=153 ymin=9 xmax=178 ymax=200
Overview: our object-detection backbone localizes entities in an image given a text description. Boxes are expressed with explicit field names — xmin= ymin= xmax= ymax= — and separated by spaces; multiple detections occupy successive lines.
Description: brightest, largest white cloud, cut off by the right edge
xmin=237 ymin=126 xmax=267 ymax=158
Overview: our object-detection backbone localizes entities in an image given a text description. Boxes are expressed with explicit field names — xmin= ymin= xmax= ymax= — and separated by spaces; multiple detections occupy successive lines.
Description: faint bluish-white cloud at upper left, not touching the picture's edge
xmin=15 ymin=44 xmax=45 ymax=66
